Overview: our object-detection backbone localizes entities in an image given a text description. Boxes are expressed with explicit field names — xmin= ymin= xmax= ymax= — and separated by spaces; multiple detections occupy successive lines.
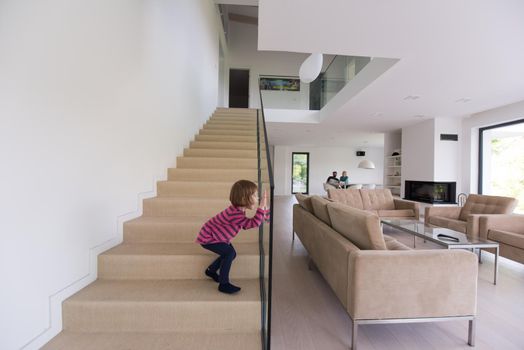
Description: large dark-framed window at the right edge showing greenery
xmin=478 ymin=119 xmax=524 ymax=213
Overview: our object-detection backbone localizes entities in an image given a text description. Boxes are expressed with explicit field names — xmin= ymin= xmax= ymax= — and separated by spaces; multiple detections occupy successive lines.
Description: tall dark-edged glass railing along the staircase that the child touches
xmin=257 ymin=91 xmax=275 ymax=350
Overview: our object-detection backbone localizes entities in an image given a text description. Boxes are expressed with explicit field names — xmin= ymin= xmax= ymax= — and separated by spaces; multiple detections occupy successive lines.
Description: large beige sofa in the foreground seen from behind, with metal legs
xmin=293 ymin=195 xmax=478 ymax=349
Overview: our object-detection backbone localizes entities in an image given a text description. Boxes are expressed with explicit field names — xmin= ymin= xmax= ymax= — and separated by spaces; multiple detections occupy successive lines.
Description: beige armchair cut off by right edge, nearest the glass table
xmin=479 ymin=214 xmax=524 ymax=264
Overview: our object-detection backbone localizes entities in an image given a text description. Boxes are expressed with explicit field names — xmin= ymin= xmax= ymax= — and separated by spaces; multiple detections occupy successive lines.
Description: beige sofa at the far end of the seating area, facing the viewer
xmin=328 ymin=188 xmax=419 ymax=220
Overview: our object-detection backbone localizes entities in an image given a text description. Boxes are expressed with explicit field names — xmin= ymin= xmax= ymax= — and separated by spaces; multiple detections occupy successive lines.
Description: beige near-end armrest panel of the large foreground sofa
xmin=347 ymin=250 xmax=478 ymax=320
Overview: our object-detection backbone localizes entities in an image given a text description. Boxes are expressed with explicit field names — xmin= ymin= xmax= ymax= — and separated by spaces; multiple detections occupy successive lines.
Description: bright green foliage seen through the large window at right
xmin=491 ymin=136 xmax=524 ymax=213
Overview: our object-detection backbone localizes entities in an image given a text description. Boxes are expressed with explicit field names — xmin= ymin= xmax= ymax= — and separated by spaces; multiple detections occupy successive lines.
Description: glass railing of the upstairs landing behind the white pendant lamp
xmin=259 ymin=56 xmax=371 ymax=111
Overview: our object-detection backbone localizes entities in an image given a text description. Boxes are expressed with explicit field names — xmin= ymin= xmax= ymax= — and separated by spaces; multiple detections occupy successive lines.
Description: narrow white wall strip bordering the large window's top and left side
xmin=461 ymin=101 xmax=524 ymax=193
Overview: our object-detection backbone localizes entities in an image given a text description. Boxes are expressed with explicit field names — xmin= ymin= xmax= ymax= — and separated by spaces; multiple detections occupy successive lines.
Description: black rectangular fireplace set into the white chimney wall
xmin=405 ymin=181 xmax=457 ymax=204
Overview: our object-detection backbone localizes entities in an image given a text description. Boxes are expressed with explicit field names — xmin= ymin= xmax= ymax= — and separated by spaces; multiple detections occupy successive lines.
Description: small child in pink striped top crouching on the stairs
xmin=196 ymin=180 xmax=269 ymax=294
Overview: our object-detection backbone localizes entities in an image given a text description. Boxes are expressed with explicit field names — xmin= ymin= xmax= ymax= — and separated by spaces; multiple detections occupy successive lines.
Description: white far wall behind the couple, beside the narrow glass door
xmin=274 ymin=145 xmax=384 ymax=195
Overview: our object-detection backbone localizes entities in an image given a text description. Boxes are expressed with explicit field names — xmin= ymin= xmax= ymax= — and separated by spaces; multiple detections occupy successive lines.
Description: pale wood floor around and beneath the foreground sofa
xmin=271 ymin=196 xmax=524 ymax=350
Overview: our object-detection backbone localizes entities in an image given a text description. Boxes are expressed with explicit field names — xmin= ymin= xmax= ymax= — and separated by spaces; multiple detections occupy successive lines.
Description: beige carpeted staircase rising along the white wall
xmin=43 ymin=109 xmax=267 ymax=350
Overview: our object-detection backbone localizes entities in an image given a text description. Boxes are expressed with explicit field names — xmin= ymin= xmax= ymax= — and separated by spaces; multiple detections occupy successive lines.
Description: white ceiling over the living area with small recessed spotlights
xmin=258 ymin=0 xmax=524 ymax=132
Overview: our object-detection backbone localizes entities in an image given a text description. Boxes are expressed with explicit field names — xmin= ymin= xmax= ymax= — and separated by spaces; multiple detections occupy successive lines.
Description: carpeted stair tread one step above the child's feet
xmin=100 ymin=242 xmax=259 ymax=256
